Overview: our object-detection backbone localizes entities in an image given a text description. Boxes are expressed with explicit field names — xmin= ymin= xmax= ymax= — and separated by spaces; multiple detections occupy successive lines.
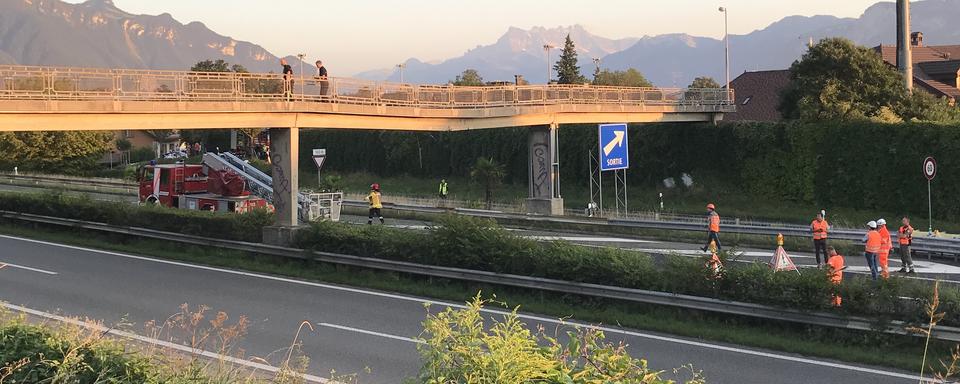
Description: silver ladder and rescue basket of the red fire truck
xmin=203 ymin=152 xmax=340 ymax=221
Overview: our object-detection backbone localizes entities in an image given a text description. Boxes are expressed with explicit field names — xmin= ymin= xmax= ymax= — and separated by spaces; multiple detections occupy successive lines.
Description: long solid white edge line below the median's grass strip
xmin=0 ymin=235 xmax=915 ymax=379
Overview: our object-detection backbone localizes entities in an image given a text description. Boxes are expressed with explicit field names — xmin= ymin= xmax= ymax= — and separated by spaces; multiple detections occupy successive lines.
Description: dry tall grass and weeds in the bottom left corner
xmin=0 ymin=304 xmax=330 ymax=384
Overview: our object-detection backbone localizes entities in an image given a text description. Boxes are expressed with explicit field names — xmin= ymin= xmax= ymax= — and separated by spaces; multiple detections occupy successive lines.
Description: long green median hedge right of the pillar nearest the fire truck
xmin=297 ymin=216 xmax=960 ymax=326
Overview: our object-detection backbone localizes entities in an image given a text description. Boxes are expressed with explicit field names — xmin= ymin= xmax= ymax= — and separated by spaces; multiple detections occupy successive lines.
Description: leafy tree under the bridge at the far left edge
xmin=0 ymin=131 xmax=114 ymax=173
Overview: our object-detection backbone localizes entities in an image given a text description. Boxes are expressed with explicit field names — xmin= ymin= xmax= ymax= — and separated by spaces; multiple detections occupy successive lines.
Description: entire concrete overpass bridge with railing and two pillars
xmin=0 ymin=66 xmax=735 ymax=240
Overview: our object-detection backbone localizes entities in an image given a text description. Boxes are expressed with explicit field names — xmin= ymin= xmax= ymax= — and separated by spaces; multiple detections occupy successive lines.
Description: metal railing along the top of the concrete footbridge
xmin=0 ymin=66 xmax=734 ymax=112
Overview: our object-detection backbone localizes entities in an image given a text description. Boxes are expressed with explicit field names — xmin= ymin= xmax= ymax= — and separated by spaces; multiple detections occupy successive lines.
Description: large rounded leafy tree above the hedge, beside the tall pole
xmin=780 ymin=38 xmax=908 ymax=120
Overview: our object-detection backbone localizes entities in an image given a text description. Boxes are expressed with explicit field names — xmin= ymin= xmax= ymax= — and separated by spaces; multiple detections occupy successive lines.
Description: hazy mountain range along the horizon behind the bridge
xmin=0 ymin=0 xmax=960 ymax=86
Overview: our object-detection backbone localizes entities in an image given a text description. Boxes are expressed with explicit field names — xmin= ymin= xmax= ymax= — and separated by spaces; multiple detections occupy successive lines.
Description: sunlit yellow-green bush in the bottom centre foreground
xmin=418 ymin=295 xmax=704 ymax=384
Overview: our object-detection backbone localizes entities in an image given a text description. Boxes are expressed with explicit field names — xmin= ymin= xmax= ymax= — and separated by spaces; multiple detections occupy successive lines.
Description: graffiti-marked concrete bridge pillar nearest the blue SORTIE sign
xmin=527 ymin=123 xmax=563 ymax=216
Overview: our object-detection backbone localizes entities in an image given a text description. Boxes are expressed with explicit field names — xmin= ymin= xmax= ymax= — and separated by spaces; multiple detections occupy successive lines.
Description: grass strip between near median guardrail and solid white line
xmin=0 ymin=222 xmax=951 ymax=377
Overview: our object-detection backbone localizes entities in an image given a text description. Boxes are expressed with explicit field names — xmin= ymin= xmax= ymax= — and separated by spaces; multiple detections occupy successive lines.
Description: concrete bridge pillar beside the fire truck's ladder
xmin=270 ymin=128 xmax=300 ymax=227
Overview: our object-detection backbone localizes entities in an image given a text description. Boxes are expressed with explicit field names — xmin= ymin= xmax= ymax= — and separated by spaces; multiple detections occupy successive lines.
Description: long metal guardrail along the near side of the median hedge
xmin=0 ymin=211 xmax=960 ymax=342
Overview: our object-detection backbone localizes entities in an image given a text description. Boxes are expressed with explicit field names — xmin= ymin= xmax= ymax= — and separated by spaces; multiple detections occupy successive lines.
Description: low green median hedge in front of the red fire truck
xmin=0 ymin=192 xmax=273 ymax=242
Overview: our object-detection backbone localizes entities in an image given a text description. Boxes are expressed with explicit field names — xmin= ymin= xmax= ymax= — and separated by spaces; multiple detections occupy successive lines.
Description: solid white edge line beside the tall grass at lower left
xmin=0 ymin=302 xmax=338 ymax=384
